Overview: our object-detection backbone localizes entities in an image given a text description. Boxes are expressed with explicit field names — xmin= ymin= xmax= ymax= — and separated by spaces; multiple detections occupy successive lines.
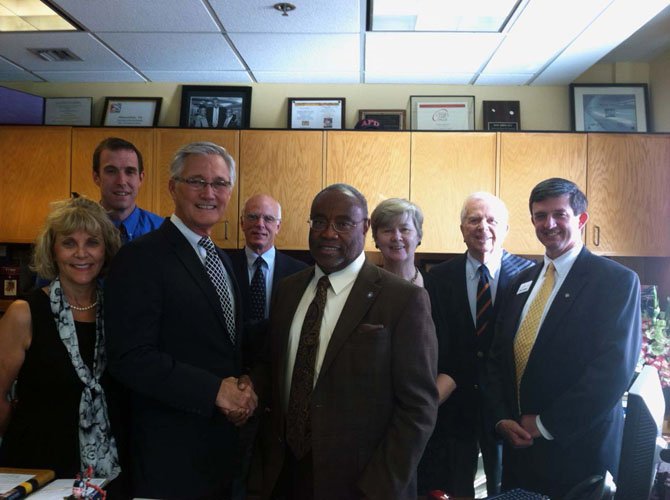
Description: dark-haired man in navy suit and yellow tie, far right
xmin=487 ymin=178 xmax=641 ymax=498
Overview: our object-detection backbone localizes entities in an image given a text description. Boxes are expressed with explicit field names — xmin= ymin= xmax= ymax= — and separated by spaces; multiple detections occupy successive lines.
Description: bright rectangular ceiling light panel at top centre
xmin=372 ymin=0 xmax=519 ymax=32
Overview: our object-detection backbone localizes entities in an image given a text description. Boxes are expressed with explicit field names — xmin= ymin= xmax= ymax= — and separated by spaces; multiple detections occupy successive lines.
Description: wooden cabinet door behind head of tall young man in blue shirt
xmin=72 ymin=127 xmax=154 ymax=211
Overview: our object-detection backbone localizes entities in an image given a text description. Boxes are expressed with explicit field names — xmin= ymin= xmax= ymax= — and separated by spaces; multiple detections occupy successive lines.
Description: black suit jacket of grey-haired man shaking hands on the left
xmin=105 ymin=220 xmax=244 ymax=498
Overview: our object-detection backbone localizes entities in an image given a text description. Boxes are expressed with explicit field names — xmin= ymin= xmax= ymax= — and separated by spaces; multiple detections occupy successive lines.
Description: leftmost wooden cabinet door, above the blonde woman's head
xmin=0 ymin=127 xmax=72 ymax=243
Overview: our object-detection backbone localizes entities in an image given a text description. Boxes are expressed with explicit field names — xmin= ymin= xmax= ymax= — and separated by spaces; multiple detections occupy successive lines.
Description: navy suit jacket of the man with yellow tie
xmin=486 ymin=248 xmax=641 ymax=497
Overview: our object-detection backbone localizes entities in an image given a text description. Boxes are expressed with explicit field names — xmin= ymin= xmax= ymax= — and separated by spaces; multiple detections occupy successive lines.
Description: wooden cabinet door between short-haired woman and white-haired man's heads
xmin=410 ymin=132 xmax=496 ymax=253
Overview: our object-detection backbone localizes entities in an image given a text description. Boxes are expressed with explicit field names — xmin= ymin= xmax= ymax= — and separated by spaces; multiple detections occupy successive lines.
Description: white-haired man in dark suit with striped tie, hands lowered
xmin=419 ymin=192 xmax=533 ymax=498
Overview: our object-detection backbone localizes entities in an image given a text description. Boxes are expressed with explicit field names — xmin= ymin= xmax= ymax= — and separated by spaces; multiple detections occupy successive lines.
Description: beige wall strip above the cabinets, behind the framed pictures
xmin=5 ymin=53 xmax=670 ymax=132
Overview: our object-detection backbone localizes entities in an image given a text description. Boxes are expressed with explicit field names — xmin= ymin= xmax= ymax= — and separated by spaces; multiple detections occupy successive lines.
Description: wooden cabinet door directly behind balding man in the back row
xmin=240 ymin=130 xmax=323 ymax=250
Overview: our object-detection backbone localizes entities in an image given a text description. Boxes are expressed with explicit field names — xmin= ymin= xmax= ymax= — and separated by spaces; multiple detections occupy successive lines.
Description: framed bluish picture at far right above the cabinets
xmin=570 ymin=83 xmax=651 ymax=132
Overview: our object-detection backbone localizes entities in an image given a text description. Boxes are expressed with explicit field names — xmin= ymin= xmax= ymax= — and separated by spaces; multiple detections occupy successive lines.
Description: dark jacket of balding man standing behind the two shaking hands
xmin=230 ymin=249 xmax=307 ymax=366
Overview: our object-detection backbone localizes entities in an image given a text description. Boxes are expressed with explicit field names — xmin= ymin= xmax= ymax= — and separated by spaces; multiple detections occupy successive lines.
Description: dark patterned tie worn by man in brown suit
xmin=286 ymin=276 xmax=330 ymax=459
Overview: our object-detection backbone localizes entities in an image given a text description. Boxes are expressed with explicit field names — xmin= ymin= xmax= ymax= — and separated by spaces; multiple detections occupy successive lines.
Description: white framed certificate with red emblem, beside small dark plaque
xmin=409 ymin=95 xmax=475 ymax=130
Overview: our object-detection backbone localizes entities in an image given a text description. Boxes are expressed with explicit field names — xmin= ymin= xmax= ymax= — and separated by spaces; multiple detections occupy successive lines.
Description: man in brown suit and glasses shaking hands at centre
xmin=255 ymin=184 xmax=438 ymax=500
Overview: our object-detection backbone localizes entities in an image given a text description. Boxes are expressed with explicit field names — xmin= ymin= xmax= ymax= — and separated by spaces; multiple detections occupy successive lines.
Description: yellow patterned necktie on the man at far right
xmin=514 ymin=262 xmax=556 ymax=408
